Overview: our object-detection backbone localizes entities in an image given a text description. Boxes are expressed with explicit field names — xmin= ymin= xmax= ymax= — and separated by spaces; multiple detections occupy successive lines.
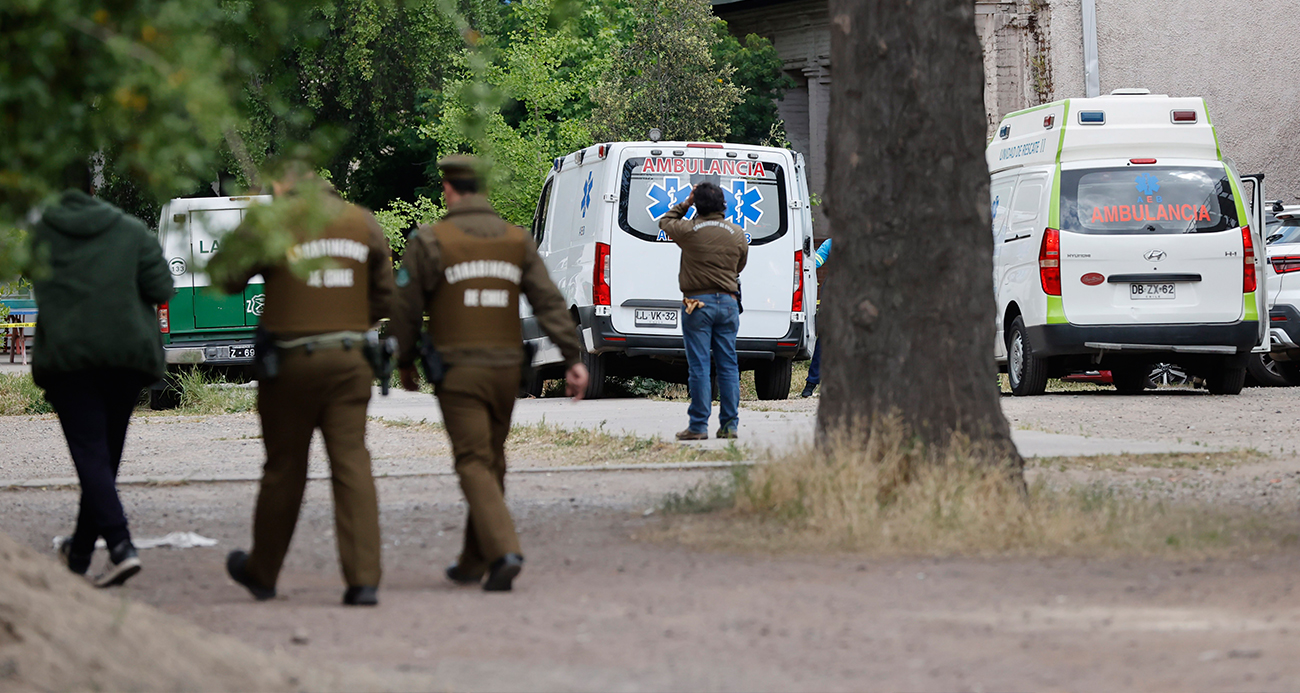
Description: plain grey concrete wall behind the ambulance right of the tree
xmin=1076 ymin=0 xmax=1300 ymax=204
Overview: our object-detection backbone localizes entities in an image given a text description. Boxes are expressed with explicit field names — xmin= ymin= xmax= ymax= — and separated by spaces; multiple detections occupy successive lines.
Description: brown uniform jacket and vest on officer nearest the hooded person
xmin=221 ymin=194 xmax=394 ymax=338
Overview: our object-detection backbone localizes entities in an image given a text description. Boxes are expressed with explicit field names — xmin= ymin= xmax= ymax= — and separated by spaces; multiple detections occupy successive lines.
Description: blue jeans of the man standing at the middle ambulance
xmin=681 ymin=294 xmax=740 ymax=433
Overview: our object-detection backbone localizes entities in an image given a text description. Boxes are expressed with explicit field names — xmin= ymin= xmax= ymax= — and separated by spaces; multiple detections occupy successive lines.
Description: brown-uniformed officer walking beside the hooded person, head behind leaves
xmin=209 ymin=165 xmax=394 ymax=606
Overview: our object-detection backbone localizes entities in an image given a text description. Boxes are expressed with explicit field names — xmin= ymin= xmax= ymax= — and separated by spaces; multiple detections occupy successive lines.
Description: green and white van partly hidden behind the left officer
xmin=150 ymin=195 xmax=270 ymax=410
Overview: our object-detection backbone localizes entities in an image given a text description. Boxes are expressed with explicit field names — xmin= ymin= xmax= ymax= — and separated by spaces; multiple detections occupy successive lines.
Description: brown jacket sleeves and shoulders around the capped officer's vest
xmin=389 ymin=194 xmax=580 ymax=368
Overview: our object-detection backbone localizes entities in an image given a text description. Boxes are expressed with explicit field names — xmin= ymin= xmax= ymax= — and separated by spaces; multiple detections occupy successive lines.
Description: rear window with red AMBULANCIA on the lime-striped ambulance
xmin=1061 ymin=166 xmax=1239 ymax=235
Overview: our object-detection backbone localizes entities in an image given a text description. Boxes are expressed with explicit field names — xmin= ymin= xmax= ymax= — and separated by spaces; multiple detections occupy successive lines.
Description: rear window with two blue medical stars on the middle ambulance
xmin=619 ymin=156 xmax=789 ymax=246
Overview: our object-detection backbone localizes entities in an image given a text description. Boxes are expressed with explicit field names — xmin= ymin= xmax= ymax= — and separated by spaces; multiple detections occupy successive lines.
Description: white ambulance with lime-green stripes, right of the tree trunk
xmin=987 ymin=90 xmax=1268 ymax=395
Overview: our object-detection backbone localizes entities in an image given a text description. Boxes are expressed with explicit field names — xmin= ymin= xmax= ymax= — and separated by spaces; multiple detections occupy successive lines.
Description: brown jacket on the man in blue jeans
xmin=659 ymin=203 xmax=749 ymax=296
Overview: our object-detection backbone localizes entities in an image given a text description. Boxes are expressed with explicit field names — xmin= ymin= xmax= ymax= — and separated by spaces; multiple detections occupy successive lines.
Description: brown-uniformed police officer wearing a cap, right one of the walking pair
xmin=389 ymin=155 xmax=588 ymax=592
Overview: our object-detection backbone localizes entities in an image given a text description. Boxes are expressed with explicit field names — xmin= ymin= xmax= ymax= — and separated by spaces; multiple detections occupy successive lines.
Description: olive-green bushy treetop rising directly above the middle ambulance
xmin=592 ymin=0 xmax=744 ymax=142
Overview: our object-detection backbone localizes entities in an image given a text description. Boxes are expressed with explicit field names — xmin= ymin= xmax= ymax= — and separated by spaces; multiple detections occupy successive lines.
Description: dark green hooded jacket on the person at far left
xmin=31 ymin=190 xmax=174 ymax=387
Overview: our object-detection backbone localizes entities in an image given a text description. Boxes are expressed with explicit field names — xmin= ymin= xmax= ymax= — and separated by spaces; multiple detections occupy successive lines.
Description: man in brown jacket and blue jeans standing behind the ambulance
xmin=659 ymin=178 xmax=749 ymax=441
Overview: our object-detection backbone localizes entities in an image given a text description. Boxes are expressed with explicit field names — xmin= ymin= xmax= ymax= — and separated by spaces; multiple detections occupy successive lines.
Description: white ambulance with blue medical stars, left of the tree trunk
xmin=524 ymin=142 xmax=816 ymax=399
